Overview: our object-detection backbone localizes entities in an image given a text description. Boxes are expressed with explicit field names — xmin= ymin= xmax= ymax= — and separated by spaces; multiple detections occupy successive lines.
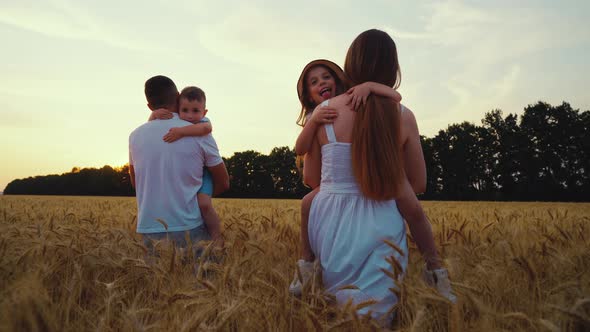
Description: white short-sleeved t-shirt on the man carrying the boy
xmin=129 ymin=113 xmax=223 ymax=233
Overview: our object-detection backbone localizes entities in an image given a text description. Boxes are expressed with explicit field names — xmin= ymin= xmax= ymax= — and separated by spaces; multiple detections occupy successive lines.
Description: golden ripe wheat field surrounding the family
xmin=0 ymin=196 xmax=590 ymax=331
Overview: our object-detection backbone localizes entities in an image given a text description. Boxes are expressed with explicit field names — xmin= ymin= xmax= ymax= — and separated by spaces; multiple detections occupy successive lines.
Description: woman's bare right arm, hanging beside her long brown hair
xmin=402 ymin=108 xmax=426 ymax=194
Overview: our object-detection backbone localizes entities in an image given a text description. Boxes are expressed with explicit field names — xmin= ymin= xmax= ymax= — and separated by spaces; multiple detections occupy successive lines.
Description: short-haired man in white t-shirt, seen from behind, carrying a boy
xmin=129 ymin=76 xmax=229 ymax=253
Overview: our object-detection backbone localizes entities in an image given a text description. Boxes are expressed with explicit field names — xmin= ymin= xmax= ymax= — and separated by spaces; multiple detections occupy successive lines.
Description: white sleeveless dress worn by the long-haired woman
xmin=308 ymin=124 xmax=408 ymax=320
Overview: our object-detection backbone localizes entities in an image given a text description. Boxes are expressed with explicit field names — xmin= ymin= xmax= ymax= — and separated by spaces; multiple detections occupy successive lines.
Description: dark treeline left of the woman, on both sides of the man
xmin=4 ymin=147 xmax=309 ymax=198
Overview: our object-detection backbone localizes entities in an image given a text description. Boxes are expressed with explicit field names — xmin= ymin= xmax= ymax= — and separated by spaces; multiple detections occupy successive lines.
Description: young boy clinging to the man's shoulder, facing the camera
xmin=149 ymin=86 xmax=224 ymax=247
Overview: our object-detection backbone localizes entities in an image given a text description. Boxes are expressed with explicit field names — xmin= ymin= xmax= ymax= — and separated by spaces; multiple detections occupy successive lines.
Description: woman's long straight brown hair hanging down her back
xmin=344 ymin=29 xmax=405 ymax=200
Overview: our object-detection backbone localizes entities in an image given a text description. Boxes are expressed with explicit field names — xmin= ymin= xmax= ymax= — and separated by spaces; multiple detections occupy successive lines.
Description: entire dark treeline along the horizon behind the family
xmin=4 ymin=102 xmax=590 ymax=201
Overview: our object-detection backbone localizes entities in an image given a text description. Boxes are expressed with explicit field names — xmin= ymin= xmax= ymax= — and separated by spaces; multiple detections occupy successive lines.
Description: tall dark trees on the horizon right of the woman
xmin=422 ymin=102 xmax=590 ymax=201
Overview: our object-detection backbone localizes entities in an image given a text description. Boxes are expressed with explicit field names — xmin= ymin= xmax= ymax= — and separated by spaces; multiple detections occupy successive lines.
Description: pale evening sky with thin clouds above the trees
xmin=0 ymin=0 xmax=590 ymax=191
